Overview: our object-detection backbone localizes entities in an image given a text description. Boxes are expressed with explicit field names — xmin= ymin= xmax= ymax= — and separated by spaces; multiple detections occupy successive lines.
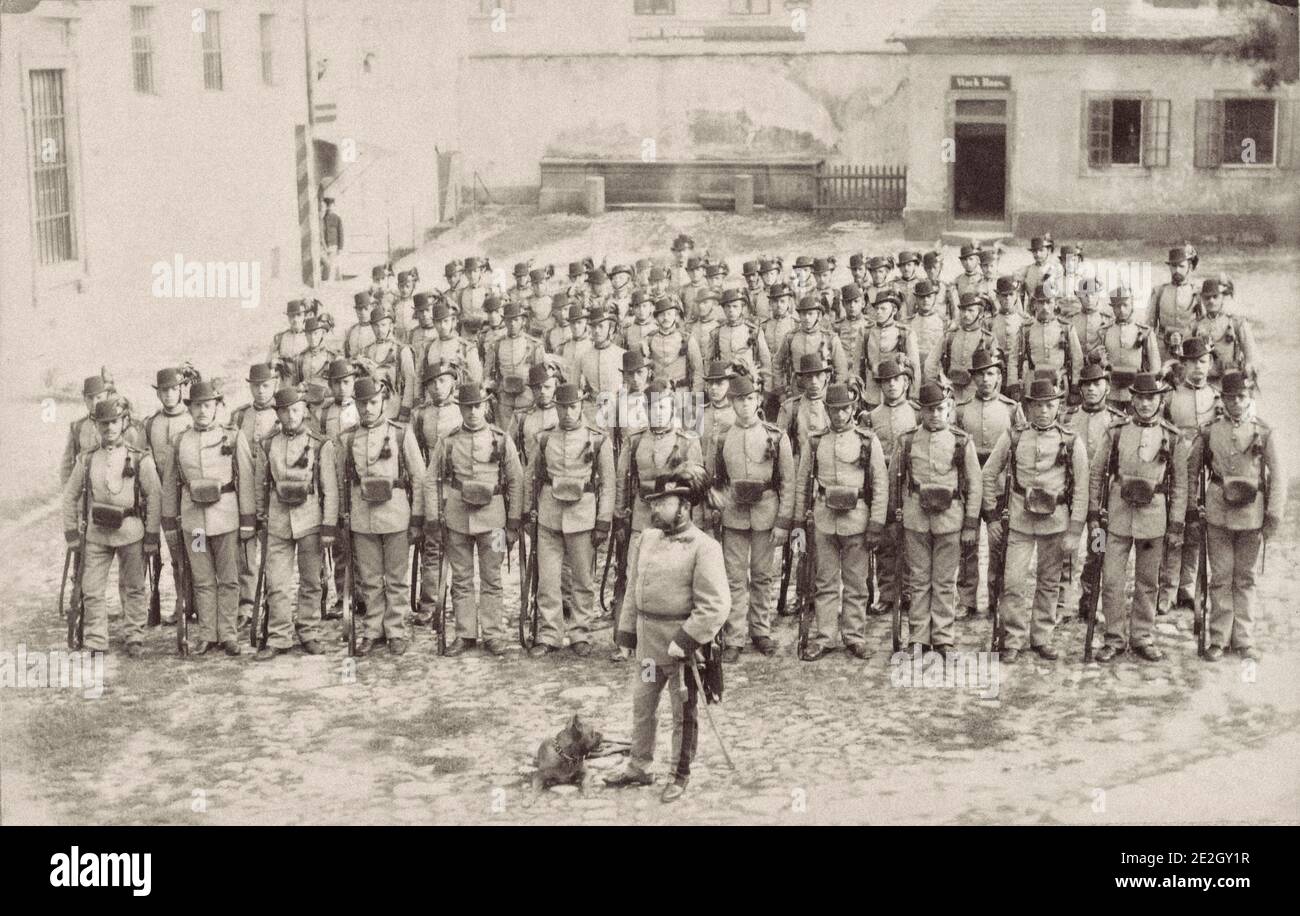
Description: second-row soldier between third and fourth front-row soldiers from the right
xmin=953 ymin=347 xmax=1028 ymax=617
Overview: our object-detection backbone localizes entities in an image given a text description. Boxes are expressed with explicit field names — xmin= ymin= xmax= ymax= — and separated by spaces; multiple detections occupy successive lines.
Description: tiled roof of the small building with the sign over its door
xmin=892 ymin=0 xmax=1248 ymax=43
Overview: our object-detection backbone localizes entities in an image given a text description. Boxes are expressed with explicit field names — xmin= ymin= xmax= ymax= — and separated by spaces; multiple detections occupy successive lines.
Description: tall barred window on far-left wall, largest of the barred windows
xmin=31 ymin=70 xmax=77 ymax=264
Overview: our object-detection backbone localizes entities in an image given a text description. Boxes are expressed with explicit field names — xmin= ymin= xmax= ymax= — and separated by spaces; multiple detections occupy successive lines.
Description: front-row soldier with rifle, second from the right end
xmin=1088 ymin=372 xmax=1188 ymax=661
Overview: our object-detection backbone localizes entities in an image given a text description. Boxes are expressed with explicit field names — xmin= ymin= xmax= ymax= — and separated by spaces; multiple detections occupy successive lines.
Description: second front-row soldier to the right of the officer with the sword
xmin=790 ymin=385 xmax=889 ymax=661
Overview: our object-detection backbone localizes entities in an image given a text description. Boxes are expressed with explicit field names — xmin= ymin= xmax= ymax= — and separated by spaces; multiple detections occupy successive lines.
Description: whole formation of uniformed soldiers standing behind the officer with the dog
xmin=64 ymin=238 xmax=1284 ymax=661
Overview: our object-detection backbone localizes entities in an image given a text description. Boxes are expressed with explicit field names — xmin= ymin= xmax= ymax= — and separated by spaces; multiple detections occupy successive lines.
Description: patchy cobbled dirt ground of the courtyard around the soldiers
xmin=0 ymin=209 xmax=1300 ymax=824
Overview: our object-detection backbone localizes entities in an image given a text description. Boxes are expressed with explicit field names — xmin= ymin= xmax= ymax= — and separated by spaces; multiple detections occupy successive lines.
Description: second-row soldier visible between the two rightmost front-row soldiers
xmin=1156 ymin=337 xmax=1223 ymax=615
